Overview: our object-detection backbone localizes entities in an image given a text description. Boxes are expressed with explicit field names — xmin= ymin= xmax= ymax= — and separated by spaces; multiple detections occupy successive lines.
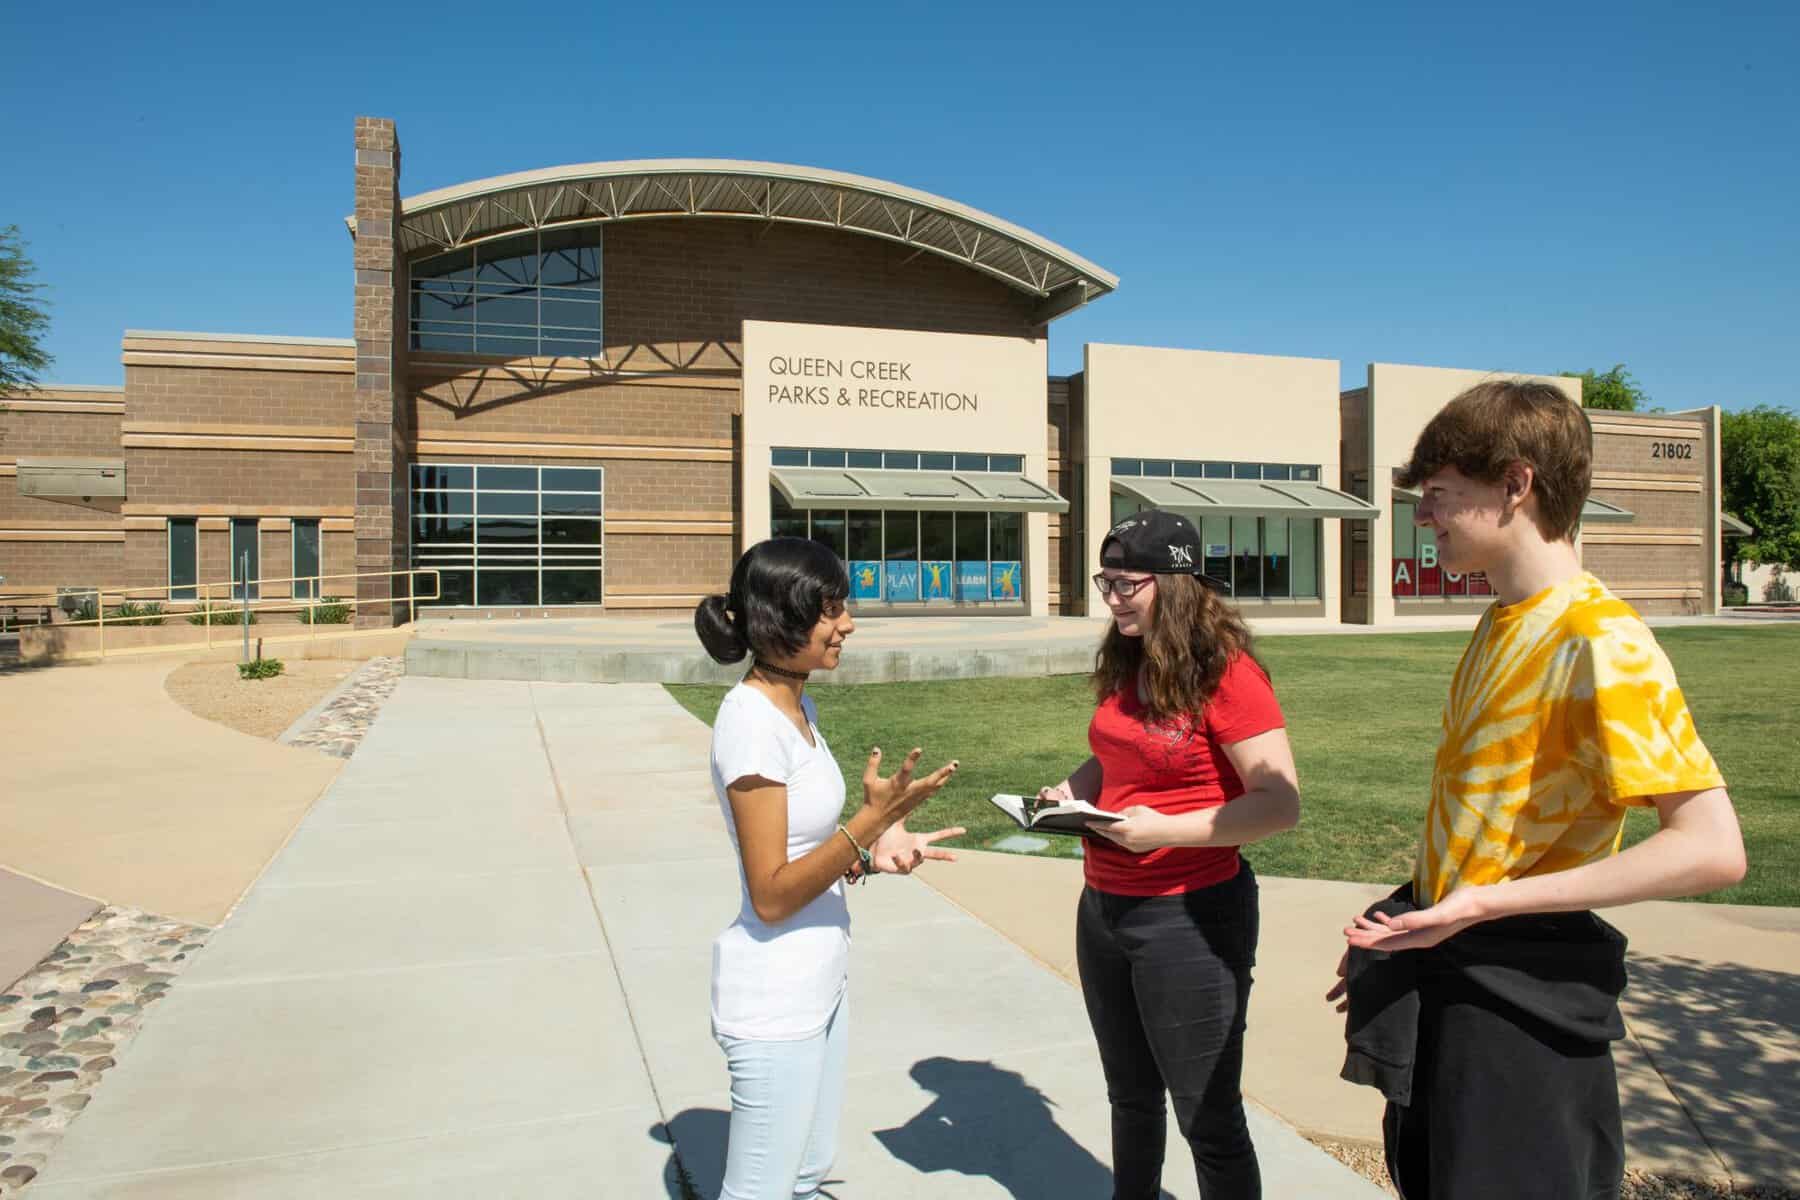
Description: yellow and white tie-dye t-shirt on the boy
xmin=1413 ymin=572 xmax=1724 ymax=905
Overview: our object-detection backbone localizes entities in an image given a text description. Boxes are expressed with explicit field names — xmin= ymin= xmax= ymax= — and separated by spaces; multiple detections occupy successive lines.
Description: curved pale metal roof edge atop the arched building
xmin=400 ymin=158 xmax=1120 ymax=291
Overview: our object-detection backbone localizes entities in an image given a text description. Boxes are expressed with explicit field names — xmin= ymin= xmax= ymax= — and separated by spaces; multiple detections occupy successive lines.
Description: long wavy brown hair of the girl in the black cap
xmin=1094 ymin=576 xmax=1260 ymax=721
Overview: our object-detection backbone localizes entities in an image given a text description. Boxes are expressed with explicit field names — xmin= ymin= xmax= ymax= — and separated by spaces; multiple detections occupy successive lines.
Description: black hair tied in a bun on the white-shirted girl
xmin=693 ymin=538 xmax=850 ymax=662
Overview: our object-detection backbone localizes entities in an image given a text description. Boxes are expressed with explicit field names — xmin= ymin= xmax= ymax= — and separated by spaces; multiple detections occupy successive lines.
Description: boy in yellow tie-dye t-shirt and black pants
xmin=1328 ymin=380 xmax=1744 ymax=1200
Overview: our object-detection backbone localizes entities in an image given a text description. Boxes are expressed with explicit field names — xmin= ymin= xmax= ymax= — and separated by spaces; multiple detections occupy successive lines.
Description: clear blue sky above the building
xmin=0 ymin=2 xmax=1800 ymax=408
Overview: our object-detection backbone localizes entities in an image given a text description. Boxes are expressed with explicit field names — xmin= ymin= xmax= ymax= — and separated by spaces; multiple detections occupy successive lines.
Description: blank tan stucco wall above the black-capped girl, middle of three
xmin=1082 ymin=344 xmax=1343 ymax=621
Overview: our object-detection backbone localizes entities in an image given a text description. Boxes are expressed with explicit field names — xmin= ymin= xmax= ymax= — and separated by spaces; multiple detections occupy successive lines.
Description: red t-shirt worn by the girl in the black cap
xmin=1085 ymin=655 xmax=1285 ymax=896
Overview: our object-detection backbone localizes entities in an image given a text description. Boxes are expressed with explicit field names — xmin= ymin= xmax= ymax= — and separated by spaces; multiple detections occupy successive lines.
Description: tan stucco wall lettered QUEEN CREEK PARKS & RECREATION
xmin=738 ymin=320 xmax=1053 ymax=615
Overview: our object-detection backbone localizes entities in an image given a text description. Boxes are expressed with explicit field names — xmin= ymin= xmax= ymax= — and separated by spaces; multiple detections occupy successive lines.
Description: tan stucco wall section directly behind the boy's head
xmin=1363 ymin=363 xmax=1580 ymax=624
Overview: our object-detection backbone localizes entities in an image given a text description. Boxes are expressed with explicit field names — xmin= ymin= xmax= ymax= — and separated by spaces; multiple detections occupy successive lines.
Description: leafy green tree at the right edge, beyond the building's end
xmin=1719 ymin=405 xmax=1800 ymax=570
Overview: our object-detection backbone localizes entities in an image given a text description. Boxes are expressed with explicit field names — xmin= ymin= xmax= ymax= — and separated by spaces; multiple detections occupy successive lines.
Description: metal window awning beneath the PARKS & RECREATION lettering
xmin=769 ymin=466 xmax=1069 ymax=513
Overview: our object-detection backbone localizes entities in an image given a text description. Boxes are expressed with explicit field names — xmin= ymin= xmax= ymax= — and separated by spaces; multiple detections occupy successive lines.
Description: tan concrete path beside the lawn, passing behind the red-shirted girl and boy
xmin=922 ymin=849 xmax=1800 ymax=1187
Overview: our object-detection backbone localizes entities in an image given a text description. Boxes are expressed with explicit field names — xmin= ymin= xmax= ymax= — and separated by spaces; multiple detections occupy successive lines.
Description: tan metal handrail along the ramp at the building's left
xmin=0 ymin=567 xmax=441 ymax=658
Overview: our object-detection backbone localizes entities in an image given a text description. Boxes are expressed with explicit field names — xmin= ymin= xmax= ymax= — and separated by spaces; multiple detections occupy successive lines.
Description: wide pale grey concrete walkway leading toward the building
xmin=32 ymin=678 xmax=1379 ymax=1200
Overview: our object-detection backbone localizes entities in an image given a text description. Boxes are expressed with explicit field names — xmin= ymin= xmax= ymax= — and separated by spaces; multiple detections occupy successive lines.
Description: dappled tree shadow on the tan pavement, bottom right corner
xmin=1620 ymin=955 xmax=1800 ymax=1182
